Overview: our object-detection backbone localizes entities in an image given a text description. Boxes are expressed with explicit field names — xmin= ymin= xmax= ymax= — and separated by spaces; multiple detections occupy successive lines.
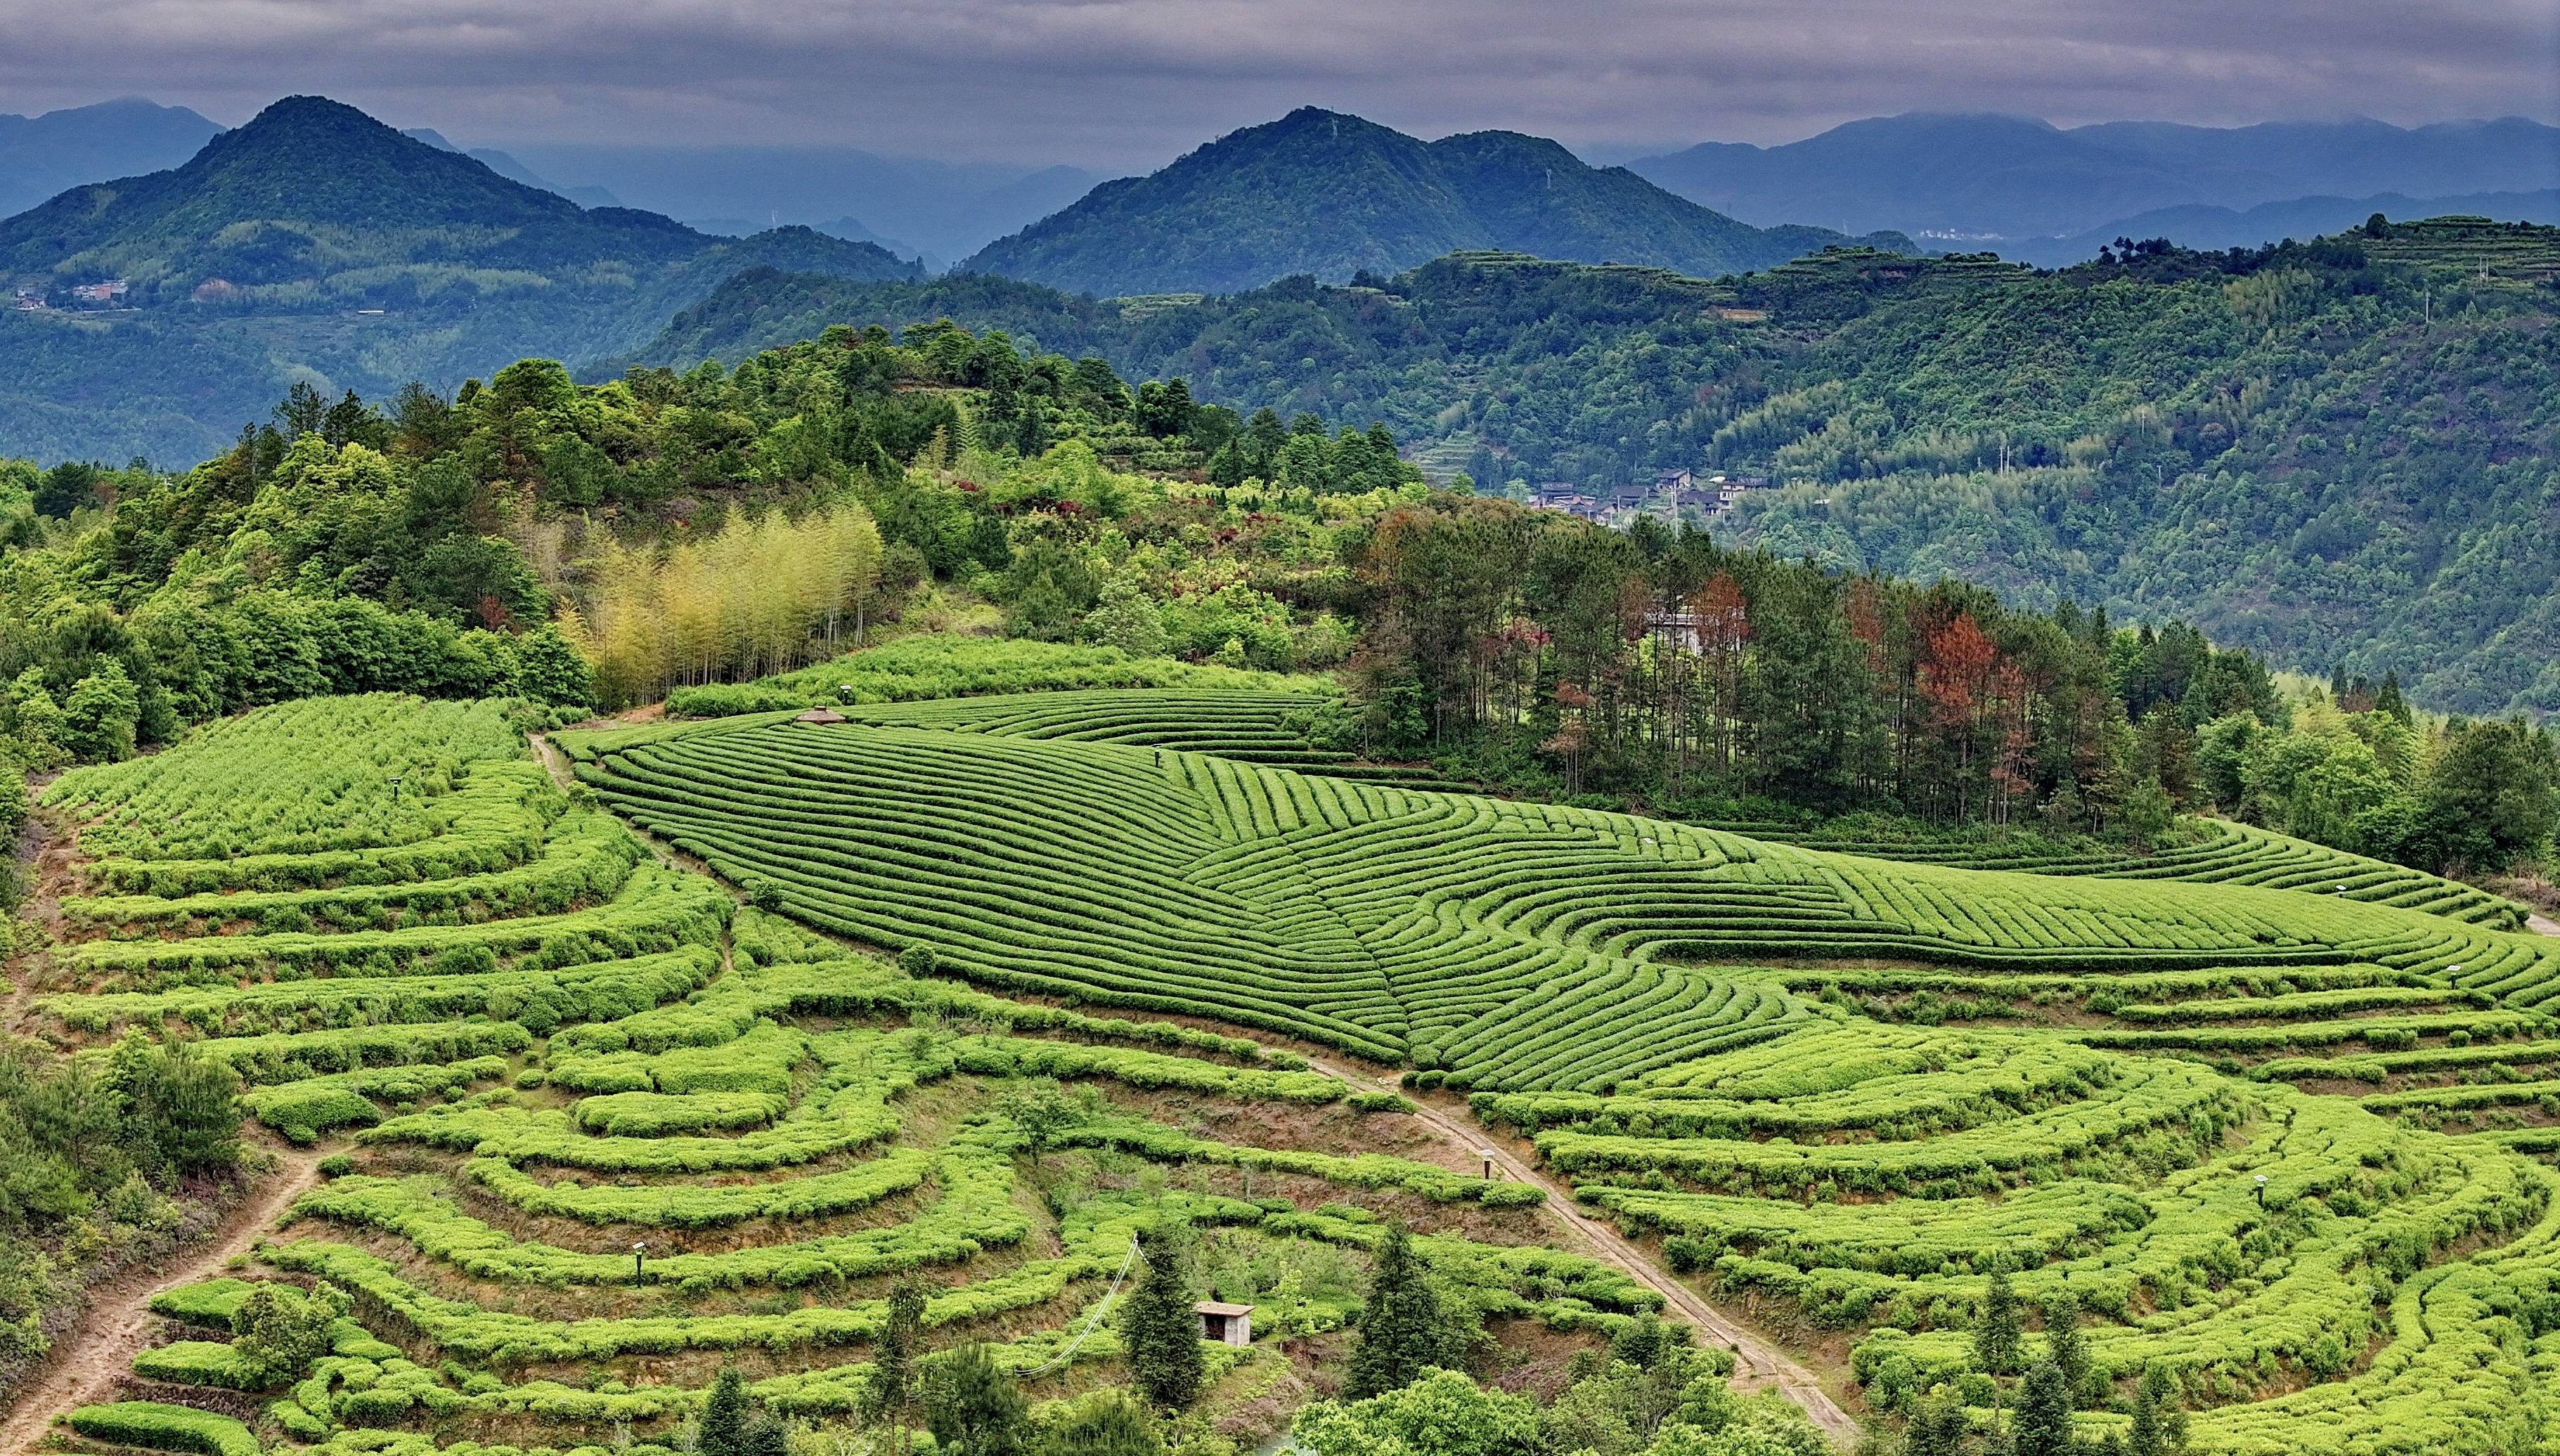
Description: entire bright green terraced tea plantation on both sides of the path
xmin=20 ymin=686 xmax=2560 ymax=1456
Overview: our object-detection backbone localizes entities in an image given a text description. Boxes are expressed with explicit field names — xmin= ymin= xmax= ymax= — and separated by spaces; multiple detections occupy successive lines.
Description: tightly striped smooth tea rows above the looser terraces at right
xmin=569 ymin=719 xmax=2555 ymax=1090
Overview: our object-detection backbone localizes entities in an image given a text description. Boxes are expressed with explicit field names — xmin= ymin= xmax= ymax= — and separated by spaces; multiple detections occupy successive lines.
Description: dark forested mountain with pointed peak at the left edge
xmin=0 ymin=97 xmax=917 ymax=463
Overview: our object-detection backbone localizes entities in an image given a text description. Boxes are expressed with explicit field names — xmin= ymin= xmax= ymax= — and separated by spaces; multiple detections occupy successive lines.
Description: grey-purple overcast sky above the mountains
xmin=0 ymin=0 xmax=2560 ymax=169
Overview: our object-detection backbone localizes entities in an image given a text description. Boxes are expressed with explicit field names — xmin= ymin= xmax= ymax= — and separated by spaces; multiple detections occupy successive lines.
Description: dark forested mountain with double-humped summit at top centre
xmin=962 ymin=108 xmax=1918 ymax=294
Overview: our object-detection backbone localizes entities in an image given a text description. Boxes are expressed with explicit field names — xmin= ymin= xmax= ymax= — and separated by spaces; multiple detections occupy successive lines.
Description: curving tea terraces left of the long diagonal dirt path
xmin=28 ymin=698 xmax=1662 ymax=1456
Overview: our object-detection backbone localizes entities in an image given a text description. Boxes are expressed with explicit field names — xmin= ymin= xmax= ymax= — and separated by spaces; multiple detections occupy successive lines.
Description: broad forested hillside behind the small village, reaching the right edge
xmin=642 ymin=220 xmax=2560 ymax=711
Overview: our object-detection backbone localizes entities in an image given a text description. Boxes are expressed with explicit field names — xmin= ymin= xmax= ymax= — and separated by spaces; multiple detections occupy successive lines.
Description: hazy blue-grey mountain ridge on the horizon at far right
xmin=1628 ymin=112 xmax=2560 ymax=246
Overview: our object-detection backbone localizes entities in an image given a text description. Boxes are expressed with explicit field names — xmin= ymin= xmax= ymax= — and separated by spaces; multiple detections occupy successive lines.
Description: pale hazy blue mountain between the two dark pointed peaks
xmin=507 ymin=143 xmax=1093 ymax=259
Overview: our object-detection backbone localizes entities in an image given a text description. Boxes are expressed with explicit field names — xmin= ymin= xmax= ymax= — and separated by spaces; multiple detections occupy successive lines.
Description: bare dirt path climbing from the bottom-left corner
xmin=0 ymin=1152 xmax=320 ymax=1456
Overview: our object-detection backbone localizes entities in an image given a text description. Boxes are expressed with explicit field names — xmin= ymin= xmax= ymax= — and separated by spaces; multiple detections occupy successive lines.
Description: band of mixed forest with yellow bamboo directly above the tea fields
xmin=0 ymin=311 xmax=2555 ymax=890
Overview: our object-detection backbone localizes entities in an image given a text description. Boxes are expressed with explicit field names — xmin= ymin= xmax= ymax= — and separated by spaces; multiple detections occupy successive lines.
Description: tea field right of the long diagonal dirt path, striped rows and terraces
xmin=569 ymin=701 xmax=2560 ymax=1451
